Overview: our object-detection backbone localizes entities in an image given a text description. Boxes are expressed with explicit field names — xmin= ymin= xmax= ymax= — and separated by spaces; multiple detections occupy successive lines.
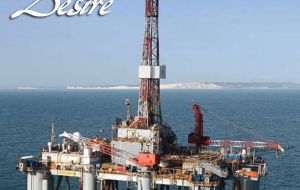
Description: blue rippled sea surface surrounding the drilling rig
xmin=0 ymin=90 xmax=300 ymax=190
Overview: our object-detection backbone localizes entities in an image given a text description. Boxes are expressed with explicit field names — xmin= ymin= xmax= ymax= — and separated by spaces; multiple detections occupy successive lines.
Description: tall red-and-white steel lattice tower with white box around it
xmin=138 ymin=0 xmax=165 ymax=127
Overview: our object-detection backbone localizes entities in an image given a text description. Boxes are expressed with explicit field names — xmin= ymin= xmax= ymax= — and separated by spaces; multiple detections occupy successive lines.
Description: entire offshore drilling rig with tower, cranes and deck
xmin=17 ymin=0 xmax=284 ymax=190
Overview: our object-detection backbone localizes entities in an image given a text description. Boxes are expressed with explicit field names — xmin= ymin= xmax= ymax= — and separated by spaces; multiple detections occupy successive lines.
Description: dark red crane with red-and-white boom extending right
xmin=188 ymin=103 xmax=284 ymax=155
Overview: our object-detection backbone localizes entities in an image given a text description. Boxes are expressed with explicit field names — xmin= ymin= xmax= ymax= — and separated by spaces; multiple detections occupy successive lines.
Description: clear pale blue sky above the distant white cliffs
xmin=0 ymin=0 xmax=300 ymax=89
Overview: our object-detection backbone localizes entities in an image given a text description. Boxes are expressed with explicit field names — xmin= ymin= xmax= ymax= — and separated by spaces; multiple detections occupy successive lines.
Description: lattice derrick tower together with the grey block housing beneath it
xmin=111 ymin=0 xmax=176 ymax=166
